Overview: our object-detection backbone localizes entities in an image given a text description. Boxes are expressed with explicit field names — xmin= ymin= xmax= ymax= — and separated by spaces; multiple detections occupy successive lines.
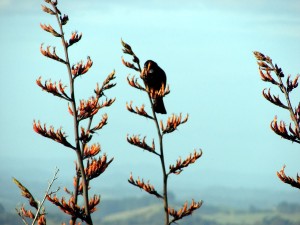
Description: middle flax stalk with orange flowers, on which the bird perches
xmin=121 ymin=41 xmax=202 ymax=225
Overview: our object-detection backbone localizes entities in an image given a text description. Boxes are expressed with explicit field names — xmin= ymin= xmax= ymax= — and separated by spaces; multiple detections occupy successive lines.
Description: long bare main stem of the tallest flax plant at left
xmin=52 ymin=4 xmax=93 ymax=225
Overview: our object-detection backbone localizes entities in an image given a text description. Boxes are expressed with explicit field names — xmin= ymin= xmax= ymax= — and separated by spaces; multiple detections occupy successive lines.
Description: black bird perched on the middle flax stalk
xmin=141 ymin=60 xmax=167 ymax=114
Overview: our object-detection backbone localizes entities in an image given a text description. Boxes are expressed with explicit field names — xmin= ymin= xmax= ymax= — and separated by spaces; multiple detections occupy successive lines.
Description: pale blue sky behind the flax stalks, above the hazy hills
xmin=0 ymin=0 xmax=300 ymax=207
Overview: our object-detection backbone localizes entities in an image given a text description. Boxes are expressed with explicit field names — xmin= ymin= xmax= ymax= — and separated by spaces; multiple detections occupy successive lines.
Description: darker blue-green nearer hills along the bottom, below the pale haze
xmin=0 ymin=196 xmax=300 ymax=225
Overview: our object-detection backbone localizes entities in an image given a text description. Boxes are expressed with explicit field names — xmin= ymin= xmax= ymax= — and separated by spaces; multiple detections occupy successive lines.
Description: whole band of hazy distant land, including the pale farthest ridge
xmin=4 ymin=186 xmax=300 ymax=225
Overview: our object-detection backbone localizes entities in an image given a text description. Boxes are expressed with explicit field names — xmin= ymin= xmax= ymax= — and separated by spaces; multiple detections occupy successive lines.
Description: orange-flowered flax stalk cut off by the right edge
xmin=254 ymin=52 xmax=300 ymax=189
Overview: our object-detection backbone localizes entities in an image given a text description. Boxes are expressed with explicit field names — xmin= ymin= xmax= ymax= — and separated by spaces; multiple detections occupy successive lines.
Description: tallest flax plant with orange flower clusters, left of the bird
xmin=13 ymin=0 xmax=115 ymax=225
